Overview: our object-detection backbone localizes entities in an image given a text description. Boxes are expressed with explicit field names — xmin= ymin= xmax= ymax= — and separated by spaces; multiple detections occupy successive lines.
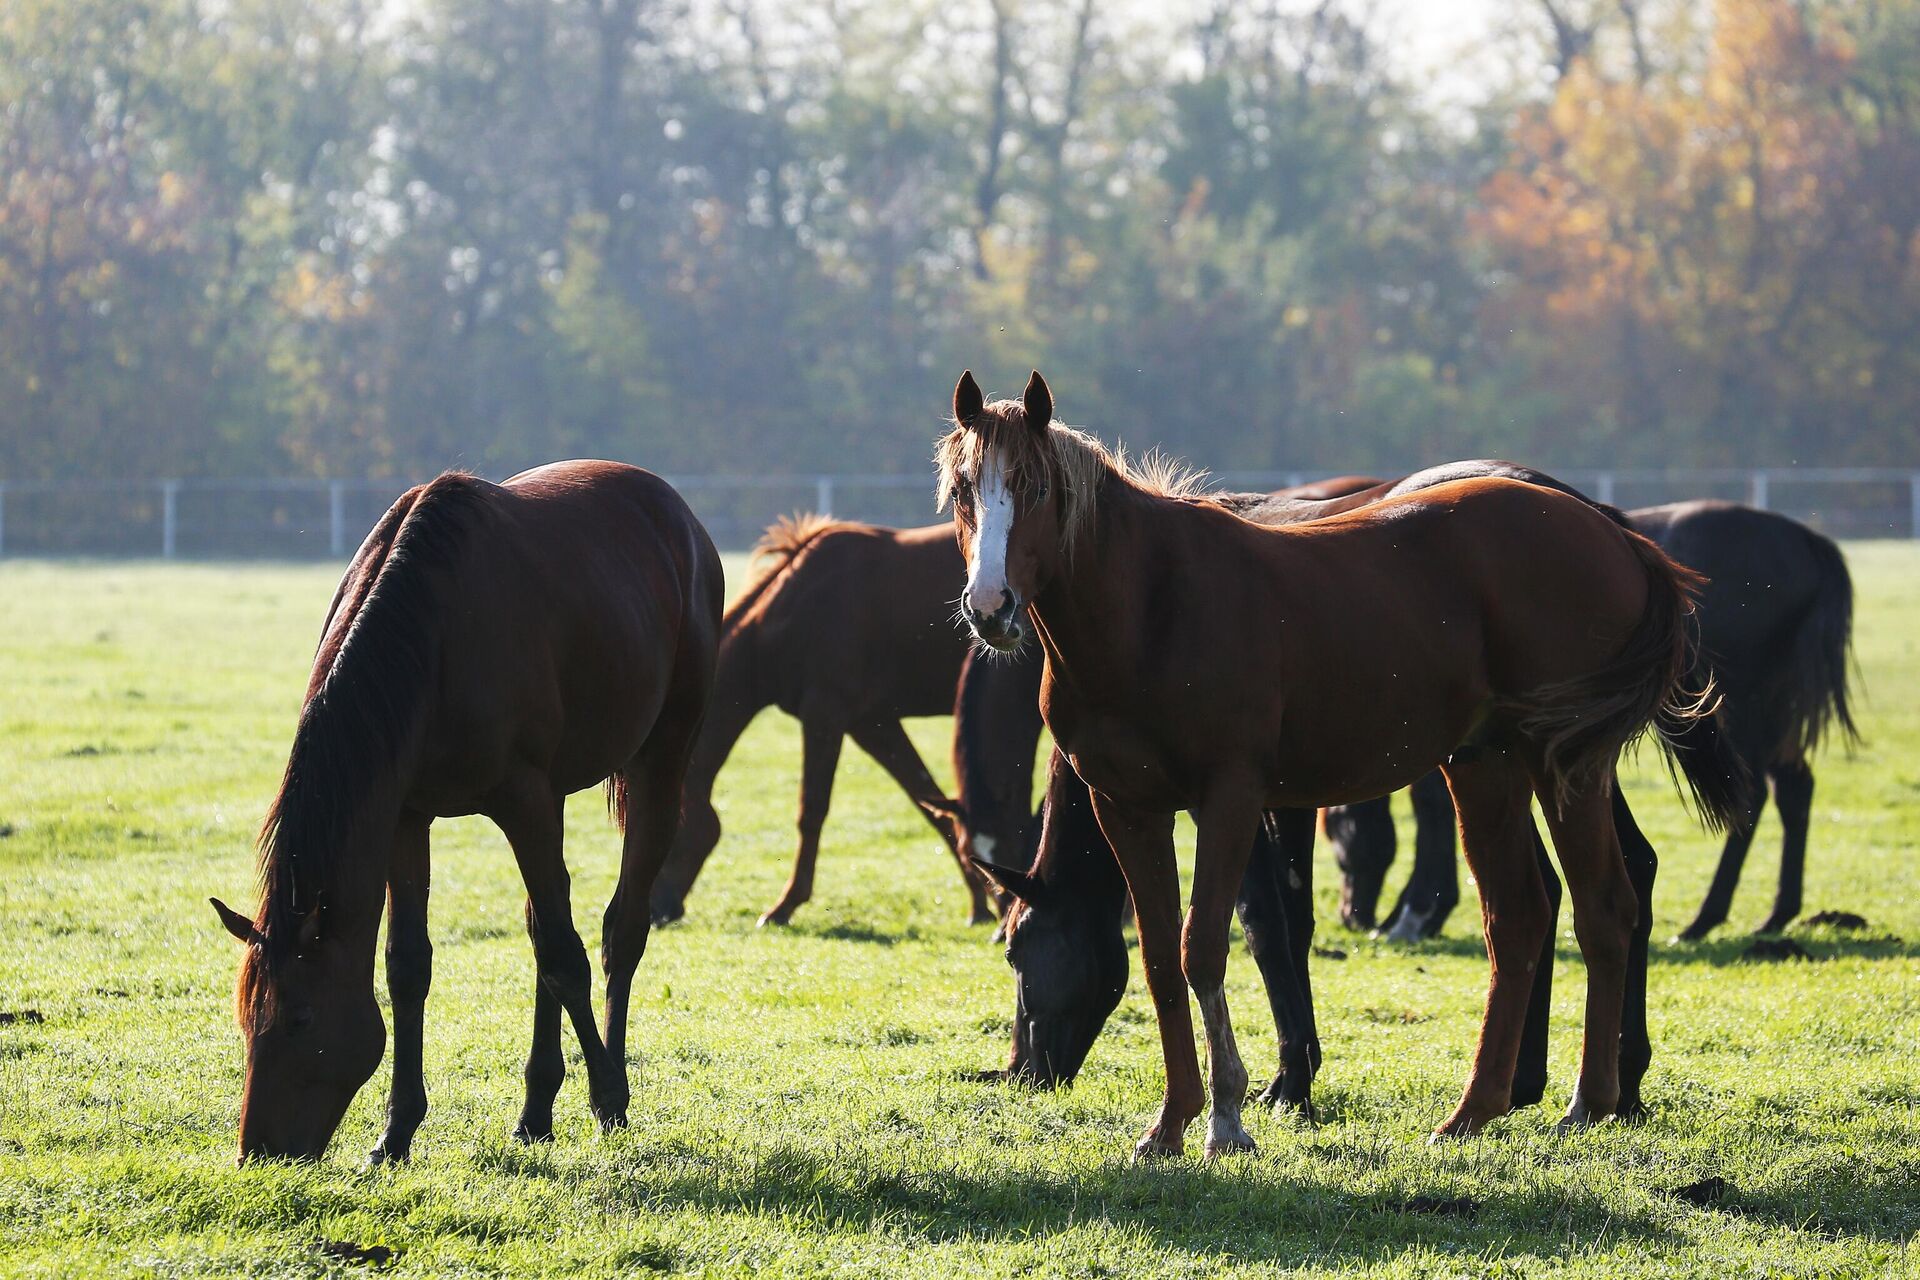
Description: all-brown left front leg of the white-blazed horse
xmin=1092 ymin=791 xmax=1190 ymax=1159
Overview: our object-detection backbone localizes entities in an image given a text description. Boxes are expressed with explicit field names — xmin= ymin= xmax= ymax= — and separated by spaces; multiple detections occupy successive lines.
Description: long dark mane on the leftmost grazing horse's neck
xmin=240 ymin=472 xmax=492 ymax=1021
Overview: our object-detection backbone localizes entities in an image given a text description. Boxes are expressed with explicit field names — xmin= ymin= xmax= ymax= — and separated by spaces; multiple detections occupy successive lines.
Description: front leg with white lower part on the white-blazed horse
xmin=1181 ymin=785 xmax=1261 ymax=1159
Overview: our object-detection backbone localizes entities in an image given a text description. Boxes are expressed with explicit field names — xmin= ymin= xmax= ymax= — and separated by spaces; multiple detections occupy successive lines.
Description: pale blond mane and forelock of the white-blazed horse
xmin=933 ymin=399 xmax=1208 ymax=557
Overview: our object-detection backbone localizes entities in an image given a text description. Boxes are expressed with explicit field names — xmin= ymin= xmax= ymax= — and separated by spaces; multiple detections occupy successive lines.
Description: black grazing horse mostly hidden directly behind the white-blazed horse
xmin=954 ymin=459 xmax=1659 ymax=1117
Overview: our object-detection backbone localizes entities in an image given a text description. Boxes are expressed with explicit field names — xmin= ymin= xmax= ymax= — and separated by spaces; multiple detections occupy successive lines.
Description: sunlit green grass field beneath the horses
xmin=0 ymin=543 xmax=1920 ymax=1276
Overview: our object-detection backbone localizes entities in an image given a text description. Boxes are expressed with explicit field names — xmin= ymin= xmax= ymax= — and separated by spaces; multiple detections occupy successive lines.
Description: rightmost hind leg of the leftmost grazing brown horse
xmin=601 ymin=741 xmax=706 ymax=1125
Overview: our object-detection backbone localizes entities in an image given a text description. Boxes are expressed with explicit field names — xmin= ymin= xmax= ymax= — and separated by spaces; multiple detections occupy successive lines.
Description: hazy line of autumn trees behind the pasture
xmin=0 ymin=0 xmax=1920 ymax=480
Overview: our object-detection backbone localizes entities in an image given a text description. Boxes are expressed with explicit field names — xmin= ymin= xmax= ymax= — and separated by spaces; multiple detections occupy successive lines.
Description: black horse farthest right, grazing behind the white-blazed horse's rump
xmin=1329 ymin=501 xmax=1859 ymax=940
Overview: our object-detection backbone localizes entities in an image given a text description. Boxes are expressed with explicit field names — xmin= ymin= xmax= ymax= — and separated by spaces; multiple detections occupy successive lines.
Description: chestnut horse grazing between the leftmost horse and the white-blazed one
xmin=653 ymin=516 xmax=998 ymax=925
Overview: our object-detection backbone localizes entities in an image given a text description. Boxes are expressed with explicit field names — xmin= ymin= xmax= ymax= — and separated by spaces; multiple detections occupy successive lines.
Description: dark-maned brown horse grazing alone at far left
xmin=213 ymin=462 xmax=726 ymax=1161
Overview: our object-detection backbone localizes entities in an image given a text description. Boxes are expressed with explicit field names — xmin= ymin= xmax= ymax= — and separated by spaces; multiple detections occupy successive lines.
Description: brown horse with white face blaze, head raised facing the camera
xmin=937 ymin=372 xmax=1738 ymax=1155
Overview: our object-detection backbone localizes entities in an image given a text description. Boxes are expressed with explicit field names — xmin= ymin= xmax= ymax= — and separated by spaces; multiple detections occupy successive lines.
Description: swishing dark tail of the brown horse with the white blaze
xmin=1507 ymin=525 xmax=1749 ymax=831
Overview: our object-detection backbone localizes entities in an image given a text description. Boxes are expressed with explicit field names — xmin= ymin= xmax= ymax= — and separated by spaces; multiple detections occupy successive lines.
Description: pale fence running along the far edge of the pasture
xmin=0 ymin=466 xmax=1920 ymax=560
